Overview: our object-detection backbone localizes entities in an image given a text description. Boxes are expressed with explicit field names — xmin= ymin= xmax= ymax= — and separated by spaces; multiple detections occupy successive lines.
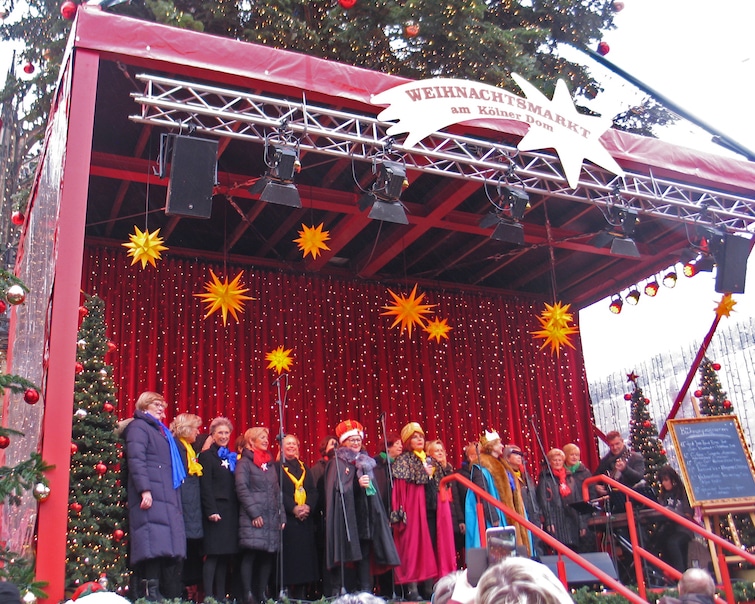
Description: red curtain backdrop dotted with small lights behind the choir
xmin=82 ymin=246 xmax=597 ymax=473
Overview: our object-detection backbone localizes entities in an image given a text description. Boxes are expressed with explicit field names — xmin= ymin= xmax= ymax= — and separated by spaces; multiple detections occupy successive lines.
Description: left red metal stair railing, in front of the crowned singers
xmin=440 ymin=474 xmax=647 ymax=604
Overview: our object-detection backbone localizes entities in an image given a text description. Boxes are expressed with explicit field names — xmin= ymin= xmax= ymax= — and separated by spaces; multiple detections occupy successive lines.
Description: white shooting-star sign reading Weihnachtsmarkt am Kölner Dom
xmin=372 ymin=74 xmax=624 ymax=188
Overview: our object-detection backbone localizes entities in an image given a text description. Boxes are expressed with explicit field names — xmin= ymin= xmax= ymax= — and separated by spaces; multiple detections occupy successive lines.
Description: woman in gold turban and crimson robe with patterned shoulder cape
xmin=391 ymin=422 xmax=456 ymax=600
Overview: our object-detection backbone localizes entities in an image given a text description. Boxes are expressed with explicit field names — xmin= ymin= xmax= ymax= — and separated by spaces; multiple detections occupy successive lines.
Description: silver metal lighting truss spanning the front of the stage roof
xmin=130 ymin=74 xmax=755 ymax=234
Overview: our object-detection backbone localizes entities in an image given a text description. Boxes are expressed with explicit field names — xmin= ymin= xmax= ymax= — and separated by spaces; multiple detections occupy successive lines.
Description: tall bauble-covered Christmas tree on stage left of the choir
xmin=66 ymin=296 xmax=129 ymax=590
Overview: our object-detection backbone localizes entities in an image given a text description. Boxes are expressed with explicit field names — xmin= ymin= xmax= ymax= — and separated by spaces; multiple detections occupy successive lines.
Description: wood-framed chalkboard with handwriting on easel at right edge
xmin=668 ymin=415 xmax=755 ymax=506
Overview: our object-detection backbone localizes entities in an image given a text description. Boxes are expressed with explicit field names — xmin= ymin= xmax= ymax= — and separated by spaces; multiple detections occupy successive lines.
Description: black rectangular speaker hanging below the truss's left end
xmin=165 ymin=136 xmax=218 ymax=218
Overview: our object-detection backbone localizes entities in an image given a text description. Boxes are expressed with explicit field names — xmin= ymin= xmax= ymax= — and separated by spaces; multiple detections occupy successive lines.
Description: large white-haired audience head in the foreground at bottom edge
xmin=475 ymin=556 xmax=573 ymax=604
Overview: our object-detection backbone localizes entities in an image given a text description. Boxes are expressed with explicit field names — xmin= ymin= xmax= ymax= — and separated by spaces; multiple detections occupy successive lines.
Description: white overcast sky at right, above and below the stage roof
xmin=580 ymin=0 xmax=755 ymax=380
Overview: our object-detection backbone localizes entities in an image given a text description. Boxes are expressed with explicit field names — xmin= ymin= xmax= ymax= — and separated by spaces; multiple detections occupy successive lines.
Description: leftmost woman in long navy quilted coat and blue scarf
xmin=124 ymin=392 xmax=186 ymax=602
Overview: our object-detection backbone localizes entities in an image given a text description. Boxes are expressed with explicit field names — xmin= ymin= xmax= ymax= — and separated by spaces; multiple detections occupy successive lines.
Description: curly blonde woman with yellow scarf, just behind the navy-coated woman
xmin=170 ymin=413 xmax=203 ymax=600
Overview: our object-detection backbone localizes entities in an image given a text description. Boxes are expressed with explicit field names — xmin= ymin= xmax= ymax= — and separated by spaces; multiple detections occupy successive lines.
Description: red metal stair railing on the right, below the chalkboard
xmin=582 ymin=475 xmax=755 ymax=604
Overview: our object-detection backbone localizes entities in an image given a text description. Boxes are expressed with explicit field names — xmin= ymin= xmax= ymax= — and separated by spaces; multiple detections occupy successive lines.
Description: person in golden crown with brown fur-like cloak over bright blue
xmin=465 ymin=430 xmax=532 ymax=554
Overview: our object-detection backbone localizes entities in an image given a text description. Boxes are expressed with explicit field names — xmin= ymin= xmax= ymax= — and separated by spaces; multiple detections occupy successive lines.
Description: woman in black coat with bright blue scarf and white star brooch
xmin=199 ymin=417 xmax=239 ymax=601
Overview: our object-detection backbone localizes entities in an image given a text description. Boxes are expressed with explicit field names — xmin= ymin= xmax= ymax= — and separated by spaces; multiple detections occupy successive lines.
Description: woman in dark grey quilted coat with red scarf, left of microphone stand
xmin=236 ymin=427 xmax=286 ymax=604
